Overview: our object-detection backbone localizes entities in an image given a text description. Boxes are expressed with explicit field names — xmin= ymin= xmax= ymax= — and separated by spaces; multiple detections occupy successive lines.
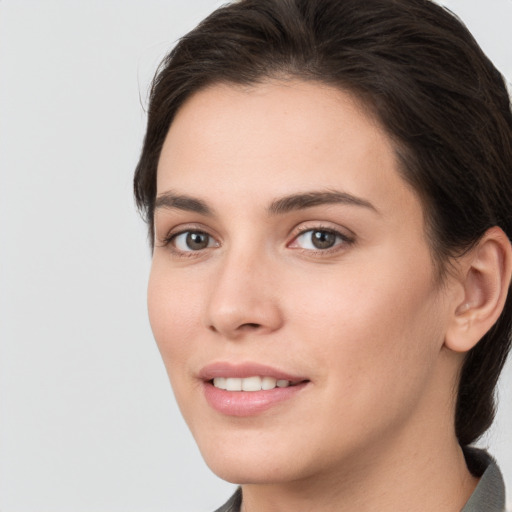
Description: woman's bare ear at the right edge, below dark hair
xmin=444 ymin=227 xmax=512 ymax=352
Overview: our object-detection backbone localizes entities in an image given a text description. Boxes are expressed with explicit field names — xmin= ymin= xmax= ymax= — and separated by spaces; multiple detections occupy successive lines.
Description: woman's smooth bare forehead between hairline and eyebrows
xmin=157 ymin=80 xmax=419 ymax=225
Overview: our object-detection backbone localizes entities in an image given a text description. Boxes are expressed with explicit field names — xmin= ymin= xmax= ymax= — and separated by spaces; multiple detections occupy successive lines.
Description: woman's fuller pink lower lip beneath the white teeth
xmin=203 ymin=381 xmax=308 ymax=416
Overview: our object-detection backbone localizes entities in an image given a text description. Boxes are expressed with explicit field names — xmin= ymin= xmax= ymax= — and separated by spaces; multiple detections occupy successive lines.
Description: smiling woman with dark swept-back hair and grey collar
xmin=135 ymin=0 xmax=512 ymax=512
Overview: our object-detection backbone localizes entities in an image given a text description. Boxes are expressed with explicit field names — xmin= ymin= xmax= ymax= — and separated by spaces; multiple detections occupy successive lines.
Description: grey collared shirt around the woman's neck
xmin=215 ymin=448 xmax=505 ymax=512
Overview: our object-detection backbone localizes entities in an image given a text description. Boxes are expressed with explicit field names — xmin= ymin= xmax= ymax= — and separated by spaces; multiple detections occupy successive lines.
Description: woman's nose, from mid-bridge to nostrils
xmin=206 ymin=245 xmax=283 ymax=339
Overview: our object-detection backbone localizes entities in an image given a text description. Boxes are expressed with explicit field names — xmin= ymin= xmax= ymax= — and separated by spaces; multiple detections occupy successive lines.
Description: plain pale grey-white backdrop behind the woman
xmin=0 ymin=0 xmax=512 ymax=512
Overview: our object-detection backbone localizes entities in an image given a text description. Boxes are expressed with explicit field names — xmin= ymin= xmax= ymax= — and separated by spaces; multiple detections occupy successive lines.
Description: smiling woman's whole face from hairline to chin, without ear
xmin=149 ymin=81 xmax=451 ymax=483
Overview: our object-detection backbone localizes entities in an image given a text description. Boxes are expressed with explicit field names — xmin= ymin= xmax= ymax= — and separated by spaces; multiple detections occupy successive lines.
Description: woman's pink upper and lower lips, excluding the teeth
xmin=199 ymin=362 xmax=309 ymax=416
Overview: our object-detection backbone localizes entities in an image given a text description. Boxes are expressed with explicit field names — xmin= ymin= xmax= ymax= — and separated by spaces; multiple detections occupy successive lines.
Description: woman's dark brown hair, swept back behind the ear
xmin=134 ymin=0 xmax=512 ymax=446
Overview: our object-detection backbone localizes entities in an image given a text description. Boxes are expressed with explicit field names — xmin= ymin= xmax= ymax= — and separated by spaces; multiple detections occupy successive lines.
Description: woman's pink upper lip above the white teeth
xmin=199 ymin=361 xmax=308 ymax=382
